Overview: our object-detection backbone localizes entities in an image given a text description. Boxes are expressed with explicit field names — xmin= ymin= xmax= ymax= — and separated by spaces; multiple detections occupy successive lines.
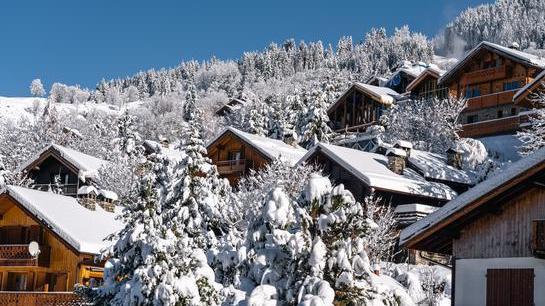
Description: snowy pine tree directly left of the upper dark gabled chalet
xmin=301 ymin=89 xmax=333 ymax=149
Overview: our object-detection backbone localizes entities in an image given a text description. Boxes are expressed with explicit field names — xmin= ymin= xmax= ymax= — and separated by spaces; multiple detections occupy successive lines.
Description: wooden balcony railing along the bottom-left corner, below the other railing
xmin=0 ymin=291 xmax=92 ymax=306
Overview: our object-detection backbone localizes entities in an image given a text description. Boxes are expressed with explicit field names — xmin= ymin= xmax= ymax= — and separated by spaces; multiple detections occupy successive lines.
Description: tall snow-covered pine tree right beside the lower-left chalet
xmin=91 ymin=155 xmax=187 ymax=306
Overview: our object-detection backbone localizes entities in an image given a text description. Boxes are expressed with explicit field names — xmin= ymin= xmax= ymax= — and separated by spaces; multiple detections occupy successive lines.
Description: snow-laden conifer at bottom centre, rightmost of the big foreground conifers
xmin=304 ymin=175 xmax=397 ymax=305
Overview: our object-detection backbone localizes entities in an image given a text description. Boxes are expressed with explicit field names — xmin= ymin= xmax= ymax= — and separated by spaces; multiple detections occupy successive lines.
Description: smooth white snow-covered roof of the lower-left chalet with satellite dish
xmin=5 ymin=186 xmax=123 ymax=254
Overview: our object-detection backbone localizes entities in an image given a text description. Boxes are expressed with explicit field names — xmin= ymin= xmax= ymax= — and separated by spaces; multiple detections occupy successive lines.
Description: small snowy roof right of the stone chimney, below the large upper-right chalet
xmin=409 ymin=149 xmax=475 ymax=185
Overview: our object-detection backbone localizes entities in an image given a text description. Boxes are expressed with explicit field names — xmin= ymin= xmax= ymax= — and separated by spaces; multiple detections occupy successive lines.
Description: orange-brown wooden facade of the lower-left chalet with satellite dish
xmin=0 ymin=194 xmax=103 ymax=297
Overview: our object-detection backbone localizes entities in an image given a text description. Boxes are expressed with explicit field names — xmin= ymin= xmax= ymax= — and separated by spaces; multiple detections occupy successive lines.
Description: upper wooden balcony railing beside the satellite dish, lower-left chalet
xmin=0 ymin=244 xmax=51 ymax=266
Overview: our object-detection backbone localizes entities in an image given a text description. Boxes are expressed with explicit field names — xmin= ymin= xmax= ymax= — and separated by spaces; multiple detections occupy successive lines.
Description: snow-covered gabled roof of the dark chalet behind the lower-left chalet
xmin=19 ymin=144 xmax=109 ymax=179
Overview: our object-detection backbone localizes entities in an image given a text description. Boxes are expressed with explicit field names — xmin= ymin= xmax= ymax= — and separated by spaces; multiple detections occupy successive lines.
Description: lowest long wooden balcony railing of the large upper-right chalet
xmin=458 ymin=116 xmax=521 ymax=137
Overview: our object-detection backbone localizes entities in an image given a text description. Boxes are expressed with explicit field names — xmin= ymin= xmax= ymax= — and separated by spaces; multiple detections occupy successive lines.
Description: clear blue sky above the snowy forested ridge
xmin=0 ymin=0 xmax=491 ymax=96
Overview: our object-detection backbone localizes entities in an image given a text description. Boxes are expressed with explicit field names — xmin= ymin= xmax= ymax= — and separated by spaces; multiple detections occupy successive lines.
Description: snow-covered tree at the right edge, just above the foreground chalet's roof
xmin=517 ymin=91 xmax=545 ymax=155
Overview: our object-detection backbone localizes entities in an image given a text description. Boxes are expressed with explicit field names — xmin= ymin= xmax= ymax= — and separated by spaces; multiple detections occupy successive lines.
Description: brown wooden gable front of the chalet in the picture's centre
xmin=207 ymin=131 xmax=271 ymax=186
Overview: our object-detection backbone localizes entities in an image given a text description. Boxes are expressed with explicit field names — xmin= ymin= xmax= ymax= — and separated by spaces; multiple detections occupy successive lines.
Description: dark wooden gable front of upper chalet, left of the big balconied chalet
xmin=327 ymin=84 xmax=389 ymax=132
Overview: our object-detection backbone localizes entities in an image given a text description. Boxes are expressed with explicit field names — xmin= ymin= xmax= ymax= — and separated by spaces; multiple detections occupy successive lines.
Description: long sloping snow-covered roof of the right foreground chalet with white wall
xmin=400 ymin=148 xmax=545 ymax=244
